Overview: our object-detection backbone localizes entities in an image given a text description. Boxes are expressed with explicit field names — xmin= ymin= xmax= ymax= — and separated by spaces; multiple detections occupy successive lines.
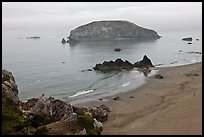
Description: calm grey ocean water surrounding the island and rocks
xmin=2 ymin=30 xmax=202 ymax=104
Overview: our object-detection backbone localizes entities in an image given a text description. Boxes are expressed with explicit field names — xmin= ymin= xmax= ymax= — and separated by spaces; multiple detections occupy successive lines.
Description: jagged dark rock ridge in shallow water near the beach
xmin=93 ymin=55 xmax=154 ymax=72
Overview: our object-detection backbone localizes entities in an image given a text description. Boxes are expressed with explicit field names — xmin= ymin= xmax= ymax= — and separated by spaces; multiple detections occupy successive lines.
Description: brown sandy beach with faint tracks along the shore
xmin=76 ymin=62 xmax=202 ymax=135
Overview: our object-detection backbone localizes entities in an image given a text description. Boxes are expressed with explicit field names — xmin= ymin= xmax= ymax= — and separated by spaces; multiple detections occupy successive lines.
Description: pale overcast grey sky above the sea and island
xmin=2 ymin=2 xmax=202 ymax=31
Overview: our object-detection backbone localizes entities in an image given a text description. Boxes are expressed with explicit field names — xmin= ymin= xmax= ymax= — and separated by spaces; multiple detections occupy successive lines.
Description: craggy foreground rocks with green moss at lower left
xmin=2 ymin=70 xmax=110 ymax=135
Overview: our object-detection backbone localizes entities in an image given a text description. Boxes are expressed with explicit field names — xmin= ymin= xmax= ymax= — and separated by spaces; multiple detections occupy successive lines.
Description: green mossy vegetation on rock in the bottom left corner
xmin=2 ymin=96 xmax=28 ymax=135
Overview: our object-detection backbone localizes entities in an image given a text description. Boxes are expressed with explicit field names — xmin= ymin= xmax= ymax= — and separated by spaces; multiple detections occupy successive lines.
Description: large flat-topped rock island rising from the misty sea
xmin=68 ymin=20 xmax=160 ymax=42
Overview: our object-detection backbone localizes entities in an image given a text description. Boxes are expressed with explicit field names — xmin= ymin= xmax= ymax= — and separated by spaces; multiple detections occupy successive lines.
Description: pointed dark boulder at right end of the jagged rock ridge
xmin=134 ymin=55 xmax=154 ymax=68
